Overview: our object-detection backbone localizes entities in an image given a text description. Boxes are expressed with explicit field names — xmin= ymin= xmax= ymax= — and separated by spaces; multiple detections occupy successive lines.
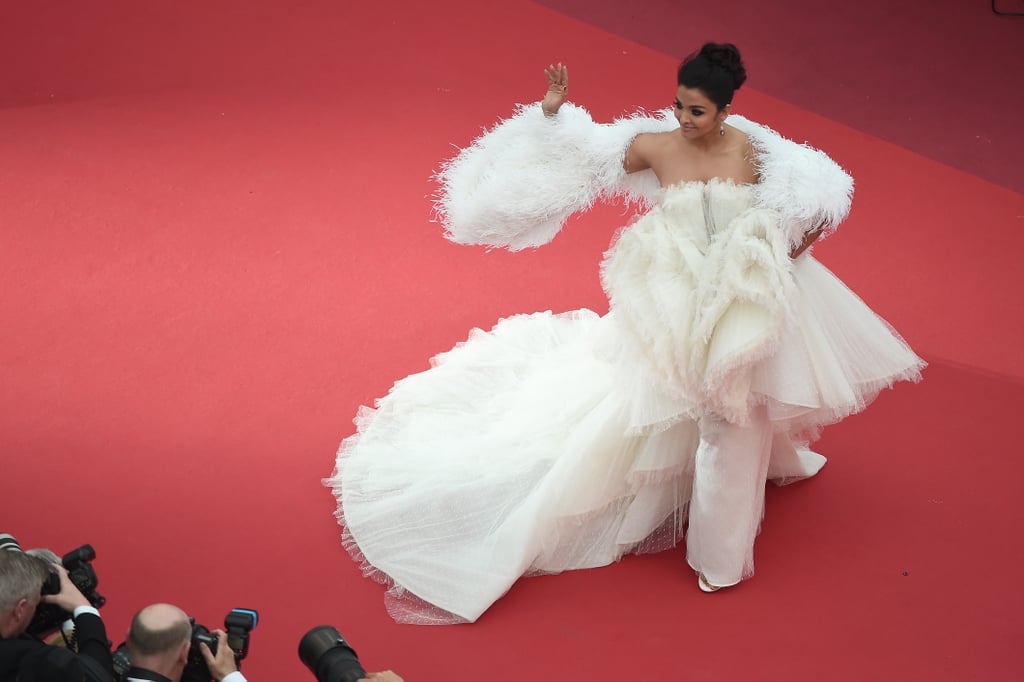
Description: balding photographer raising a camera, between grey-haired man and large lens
xmin=126 ymin=604 xmax=246 ymax=682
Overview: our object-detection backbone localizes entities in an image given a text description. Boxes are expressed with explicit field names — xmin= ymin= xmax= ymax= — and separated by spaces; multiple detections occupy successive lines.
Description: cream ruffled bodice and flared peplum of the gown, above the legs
xmin=601 ymin=180 xmax=924 ymax=434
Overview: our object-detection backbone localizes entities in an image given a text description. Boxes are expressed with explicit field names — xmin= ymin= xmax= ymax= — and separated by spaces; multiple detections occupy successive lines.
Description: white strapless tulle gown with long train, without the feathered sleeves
xmin=326 ymin=104 xmax=924 ymax=624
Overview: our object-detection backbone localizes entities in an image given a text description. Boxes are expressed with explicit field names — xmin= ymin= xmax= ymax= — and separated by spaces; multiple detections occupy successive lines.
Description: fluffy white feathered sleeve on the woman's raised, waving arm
xmin=434 ymin=103 xmax=678 ymax=251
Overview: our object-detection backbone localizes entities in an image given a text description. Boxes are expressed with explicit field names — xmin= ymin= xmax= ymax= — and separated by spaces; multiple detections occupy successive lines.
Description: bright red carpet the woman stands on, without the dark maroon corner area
xmin=0 ymin=0 xmax=1024 ymax=682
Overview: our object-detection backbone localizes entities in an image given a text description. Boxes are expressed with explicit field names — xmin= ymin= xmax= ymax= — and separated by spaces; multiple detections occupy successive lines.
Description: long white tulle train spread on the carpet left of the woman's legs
xmin=329 ymin=310 xmax=697 ymax=623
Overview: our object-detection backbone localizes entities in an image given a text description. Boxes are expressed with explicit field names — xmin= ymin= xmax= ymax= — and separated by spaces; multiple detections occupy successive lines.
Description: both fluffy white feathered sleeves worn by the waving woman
xmin=434 ymin=102 xmax=853 ymax=251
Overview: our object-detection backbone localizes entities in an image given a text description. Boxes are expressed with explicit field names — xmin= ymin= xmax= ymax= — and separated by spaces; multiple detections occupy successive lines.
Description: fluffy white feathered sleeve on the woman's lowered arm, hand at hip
xmin=728 ymin=116 xmax=853 ymax=246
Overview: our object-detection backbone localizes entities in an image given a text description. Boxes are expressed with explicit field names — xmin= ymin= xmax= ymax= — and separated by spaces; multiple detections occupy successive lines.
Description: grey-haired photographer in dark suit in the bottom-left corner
xmin=0 ymin=545 xmax=114 ymax=682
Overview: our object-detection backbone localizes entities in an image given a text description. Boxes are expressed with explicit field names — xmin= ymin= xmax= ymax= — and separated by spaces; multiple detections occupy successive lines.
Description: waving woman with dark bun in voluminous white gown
xmin=327 ymin=43 xmax=924 ymax=623
